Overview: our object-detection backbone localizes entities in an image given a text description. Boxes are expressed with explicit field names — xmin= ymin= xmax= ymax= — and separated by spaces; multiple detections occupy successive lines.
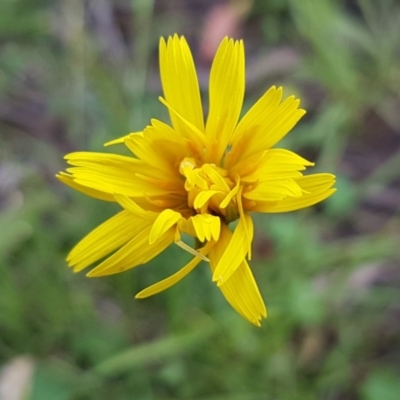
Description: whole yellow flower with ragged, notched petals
xmin=58 ymin=35 xmax=335 ymax=326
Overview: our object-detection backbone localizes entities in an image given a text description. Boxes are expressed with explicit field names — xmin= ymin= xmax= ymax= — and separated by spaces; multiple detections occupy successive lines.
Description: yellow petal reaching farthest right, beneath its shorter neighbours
xmin=252 ymin=174 xmax=336 ymax=213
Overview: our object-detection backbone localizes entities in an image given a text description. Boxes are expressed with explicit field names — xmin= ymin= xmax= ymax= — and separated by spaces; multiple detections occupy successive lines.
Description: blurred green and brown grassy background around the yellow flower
xmin=0 ymin=0 xmax=400 ymax=400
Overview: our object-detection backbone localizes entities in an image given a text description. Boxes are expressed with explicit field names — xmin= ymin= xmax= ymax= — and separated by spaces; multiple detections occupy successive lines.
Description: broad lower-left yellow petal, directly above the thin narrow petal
xmin=86 ymin=226 xmax=175 ymax=277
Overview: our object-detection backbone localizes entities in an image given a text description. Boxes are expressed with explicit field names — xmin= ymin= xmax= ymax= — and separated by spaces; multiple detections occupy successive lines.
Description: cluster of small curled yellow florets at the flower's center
xmin=179 ymin=158 xmax=241 ymax=223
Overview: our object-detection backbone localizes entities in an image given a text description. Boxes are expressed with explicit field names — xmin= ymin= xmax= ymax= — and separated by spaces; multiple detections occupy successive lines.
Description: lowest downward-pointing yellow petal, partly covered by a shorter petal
xmin=208 ymin=227 xmax=267 ymax=326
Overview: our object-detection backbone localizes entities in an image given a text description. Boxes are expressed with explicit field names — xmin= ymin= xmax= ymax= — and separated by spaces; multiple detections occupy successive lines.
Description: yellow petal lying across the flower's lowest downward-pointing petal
xmin=213 ymin=214 xmax=253 ymax=286
